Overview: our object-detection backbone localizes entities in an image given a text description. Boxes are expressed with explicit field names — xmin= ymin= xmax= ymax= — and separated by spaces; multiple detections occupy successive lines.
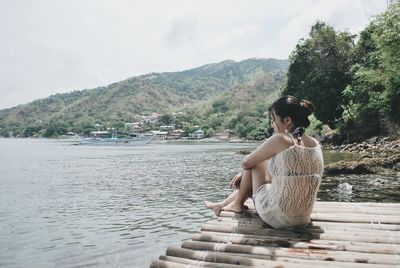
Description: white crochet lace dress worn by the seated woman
xmin=254 ymin=138 xmax=324 ymax=228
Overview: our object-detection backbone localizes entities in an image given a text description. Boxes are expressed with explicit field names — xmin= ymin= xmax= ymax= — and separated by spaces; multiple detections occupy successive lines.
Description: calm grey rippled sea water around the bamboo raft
xmin=0 ymin=139 xmax=400 ymax=267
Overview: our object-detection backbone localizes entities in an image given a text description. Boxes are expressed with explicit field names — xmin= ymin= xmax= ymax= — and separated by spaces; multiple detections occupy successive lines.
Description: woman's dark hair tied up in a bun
xmin=268 ymin=96 xmax=314 ymax=129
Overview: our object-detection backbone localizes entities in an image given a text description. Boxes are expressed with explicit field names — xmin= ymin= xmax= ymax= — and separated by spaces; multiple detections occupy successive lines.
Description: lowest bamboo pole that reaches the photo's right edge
xmin=182 ymin=241 xmax=399 ymax=265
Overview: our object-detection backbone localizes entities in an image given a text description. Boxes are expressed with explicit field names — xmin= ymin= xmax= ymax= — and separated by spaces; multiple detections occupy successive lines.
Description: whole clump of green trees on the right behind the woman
xmin=283 ymin=1 xmax=400 ymax=143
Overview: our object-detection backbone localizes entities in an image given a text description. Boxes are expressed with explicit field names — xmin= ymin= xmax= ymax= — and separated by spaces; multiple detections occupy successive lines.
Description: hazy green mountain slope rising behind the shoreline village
xmin=0 ymin=59 xmax=288 ymax=137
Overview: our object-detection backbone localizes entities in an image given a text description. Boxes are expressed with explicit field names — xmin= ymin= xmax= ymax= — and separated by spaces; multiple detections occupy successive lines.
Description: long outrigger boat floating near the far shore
xmin=76 ymin=131 xmax=151 ymax=146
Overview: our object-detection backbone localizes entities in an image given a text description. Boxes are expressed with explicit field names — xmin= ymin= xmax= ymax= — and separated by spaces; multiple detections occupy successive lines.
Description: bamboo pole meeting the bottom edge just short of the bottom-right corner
xmin=167 ymin=247 xmax=393 ymax=268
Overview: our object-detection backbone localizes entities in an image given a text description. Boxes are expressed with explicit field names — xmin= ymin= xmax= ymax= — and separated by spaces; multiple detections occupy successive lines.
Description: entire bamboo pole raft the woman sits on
xmin=151 ymin=202 xmax=400 ymax=268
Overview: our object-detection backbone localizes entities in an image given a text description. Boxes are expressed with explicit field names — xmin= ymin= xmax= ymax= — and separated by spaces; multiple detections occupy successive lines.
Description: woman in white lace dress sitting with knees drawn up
xmin=206 ymin=96 xmax=324 ymax=228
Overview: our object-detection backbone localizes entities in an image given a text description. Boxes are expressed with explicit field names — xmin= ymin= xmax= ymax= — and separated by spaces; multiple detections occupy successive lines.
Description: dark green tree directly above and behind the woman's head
xmin=283 ymin=22 xmax=354 ymax=127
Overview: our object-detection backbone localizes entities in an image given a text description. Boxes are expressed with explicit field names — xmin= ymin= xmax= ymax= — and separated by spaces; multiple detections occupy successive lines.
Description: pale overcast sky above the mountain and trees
xmin=0 ymin=0 xmax=388 ymax=109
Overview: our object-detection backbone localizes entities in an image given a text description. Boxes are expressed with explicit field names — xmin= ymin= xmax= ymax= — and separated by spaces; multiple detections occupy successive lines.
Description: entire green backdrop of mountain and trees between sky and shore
xmin=0 ymin=1 xmax=400 ymax=143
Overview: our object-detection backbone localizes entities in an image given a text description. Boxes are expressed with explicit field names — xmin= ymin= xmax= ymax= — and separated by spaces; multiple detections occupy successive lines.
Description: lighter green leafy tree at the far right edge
xmin=340 ymin=2 xmax=400 ymax=139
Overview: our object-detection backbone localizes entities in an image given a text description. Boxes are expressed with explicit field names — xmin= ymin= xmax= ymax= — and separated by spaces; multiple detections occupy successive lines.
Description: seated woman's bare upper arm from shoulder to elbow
xmin=242 ymin=134 xmax=291 ymax=169
